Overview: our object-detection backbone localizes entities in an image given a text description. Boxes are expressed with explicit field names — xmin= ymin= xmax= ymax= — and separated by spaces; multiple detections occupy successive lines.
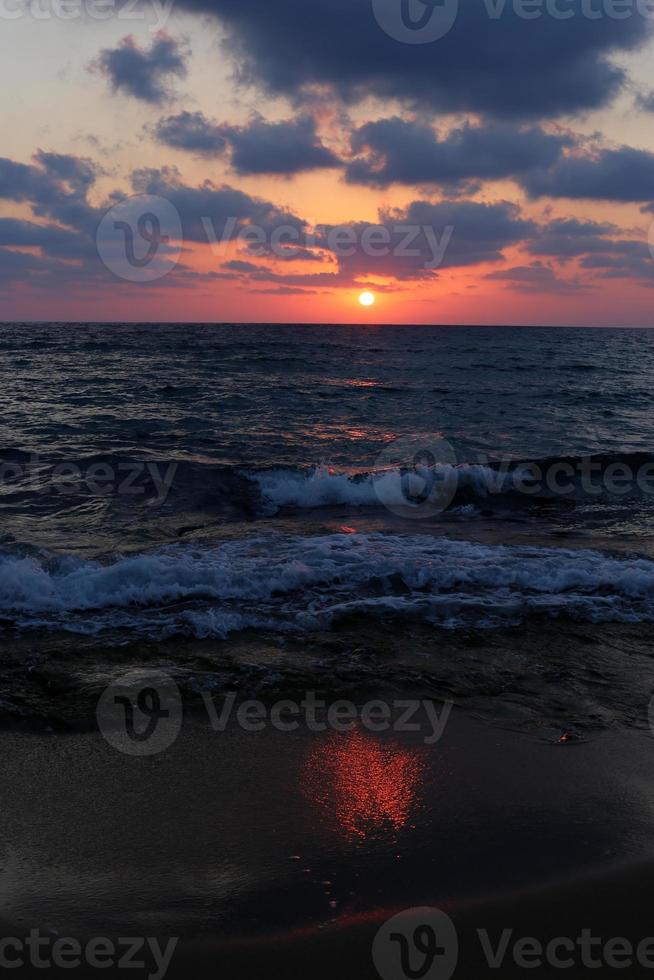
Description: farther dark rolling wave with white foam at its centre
xmin=0 ymin=446 xmax=654 ymax=553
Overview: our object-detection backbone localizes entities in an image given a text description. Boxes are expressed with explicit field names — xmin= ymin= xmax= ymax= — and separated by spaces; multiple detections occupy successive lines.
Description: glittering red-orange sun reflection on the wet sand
xmin=304 ymin=730 xmax=423 ymax=839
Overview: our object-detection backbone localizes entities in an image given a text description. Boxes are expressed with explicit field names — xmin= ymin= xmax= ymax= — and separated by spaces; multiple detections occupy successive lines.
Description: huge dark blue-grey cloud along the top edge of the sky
xmin=176 ymin=0 xmax=650 ymax=118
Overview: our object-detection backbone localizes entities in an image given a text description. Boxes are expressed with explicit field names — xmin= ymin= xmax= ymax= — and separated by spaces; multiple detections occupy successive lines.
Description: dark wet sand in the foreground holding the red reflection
xmin=0 ymin=712 xmax=654 ymax=980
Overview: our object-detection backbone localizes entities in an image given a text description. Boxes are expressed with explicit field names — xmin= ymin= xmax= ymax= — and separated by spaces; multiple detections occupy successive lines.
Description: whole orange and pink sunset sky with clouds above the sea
xmin=0 ymin=0 xmax=654 ymax=326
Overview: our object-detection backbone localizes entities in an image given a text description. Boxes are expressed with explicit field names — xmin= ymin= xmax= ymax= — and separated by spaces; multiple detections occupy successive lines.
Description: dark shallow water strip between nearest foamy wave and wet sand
xmin=0 ymin=615 xmax=654 ymax=739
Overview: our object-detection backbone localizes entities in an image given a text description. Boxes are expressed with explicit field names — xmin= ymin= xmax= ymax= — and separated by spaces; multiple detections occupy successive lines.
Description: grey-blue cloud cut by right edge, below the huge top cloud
xmin=521 ymin=146 xmax=654 ymax=202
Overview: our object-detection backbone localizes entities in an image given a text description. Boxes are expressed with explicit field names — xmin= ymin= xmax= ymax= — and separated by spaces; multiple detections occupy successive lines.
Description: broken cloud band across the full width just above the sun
xmin=0 ymin=150 xmax=654 ymax=292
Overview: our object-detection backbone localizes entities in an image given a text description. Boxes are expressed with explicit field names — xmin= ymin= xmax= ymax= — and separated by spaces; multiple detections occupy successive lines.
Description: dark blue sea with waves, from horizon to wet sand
xmin=0 ymin=324 xmax=654 ymax=725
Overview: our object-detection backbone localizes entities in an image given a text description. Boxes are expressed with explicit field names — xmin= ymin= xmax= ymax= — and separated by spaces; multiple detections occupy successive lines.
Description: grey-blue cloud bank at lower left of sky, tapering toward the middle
xmin=0 ymin=151 xmax=313 ymax=289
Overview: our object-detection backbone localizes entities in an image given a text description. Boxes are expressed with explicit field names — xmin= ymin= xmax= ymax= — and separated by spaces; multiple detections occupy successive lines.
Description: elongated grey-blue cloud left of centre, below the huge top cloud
xmin=154 ymin=112 xmax=340 ymax=176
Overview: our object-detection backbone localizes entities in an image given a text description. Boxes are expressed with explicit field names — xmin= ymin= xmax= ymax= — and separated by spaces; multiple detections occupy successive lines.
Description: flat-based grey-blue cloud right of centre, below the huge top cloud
xmin=346 ymin=116 xmax=571 ymax=186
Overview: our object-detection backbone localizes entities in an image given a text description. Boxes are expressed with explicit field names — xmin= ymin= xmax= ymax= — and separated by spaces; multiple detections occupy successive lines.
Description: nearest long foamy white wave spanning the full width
xmin=0 ymin=532 xmax=654 ymax=638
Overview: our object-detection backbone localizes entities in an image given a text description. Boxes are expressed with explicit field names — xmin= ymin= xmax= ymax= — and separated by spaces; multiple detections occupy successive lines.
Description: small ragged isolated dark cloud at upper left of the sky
xmin=92 ymin=31 xmax=188 ymax=105
